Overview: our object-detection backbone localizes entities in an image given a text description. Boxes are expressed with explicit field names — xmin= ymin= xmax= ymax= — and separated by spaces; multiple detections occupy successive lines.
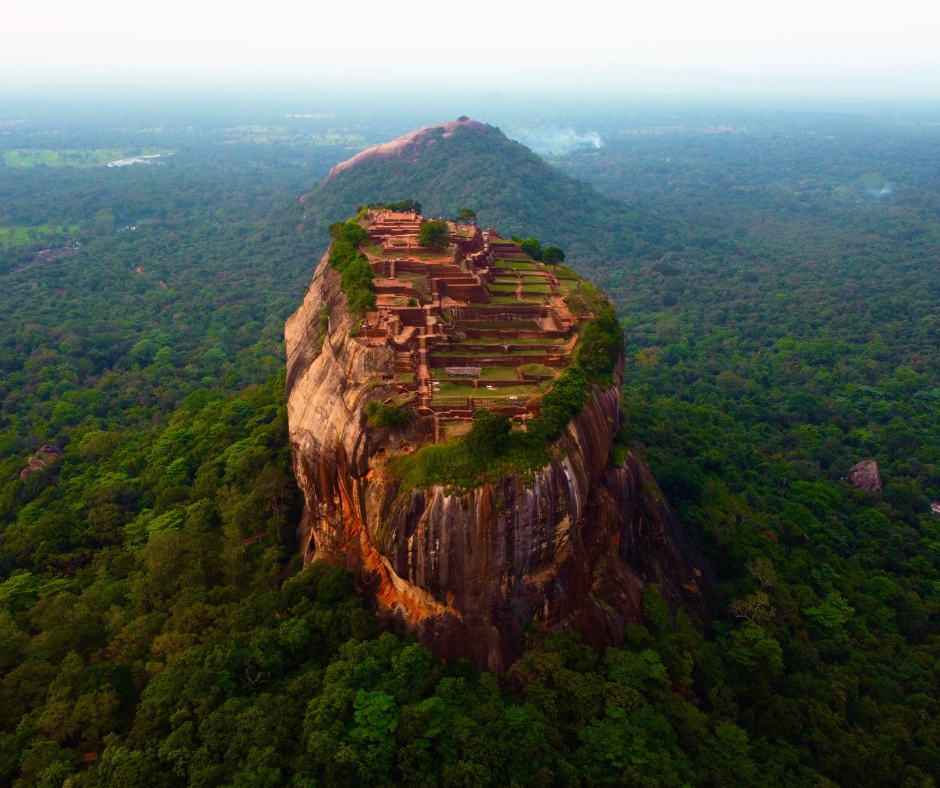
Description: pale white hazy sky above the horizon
xmin=0 ymin=0 xmax=940 ymax=93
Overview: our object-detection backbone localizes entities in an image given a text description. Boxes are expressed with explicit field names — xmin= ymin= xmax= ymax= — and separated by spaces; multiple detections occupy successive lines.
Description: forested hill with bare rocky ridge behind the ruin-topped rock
xmin=306 ymin=119 xmax=649 ymax=272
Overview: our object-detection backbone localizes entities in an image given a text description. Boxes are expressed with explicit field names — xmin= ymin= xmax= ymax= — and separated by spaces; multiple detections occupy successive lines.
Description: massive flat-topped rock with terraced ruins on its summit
xmin=285 ymin=131 xmax=711 ymax=671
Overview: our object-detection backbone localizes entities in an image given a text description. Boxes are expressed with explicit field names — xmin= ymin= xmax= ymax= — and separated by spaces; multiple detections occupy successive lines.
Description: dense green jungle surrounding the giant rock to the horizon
xmin=0 ymin=102 xmax=940 ymax=788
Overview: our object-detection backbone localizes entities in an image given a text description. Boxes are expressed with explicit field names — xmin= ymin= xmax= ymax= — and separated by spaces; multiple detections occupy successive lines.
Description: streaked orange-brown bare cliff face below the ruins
xmin=285 ymin=252 xmax=709 ymax=671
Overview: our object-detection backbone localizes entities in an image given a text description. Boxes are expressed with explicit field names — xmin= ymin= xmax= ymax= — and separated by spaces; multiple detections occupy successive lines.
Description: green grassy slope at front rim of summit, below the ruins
xmin=388 ymin=430 xmax=552 ymax=492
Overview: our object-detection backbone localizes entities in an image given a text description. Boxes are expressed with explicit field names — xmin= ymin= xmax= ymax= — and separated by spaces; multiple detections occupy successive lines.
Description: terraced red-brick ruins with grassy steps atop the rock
xmin=356 ymin=209 xmax=592 ymax=442
